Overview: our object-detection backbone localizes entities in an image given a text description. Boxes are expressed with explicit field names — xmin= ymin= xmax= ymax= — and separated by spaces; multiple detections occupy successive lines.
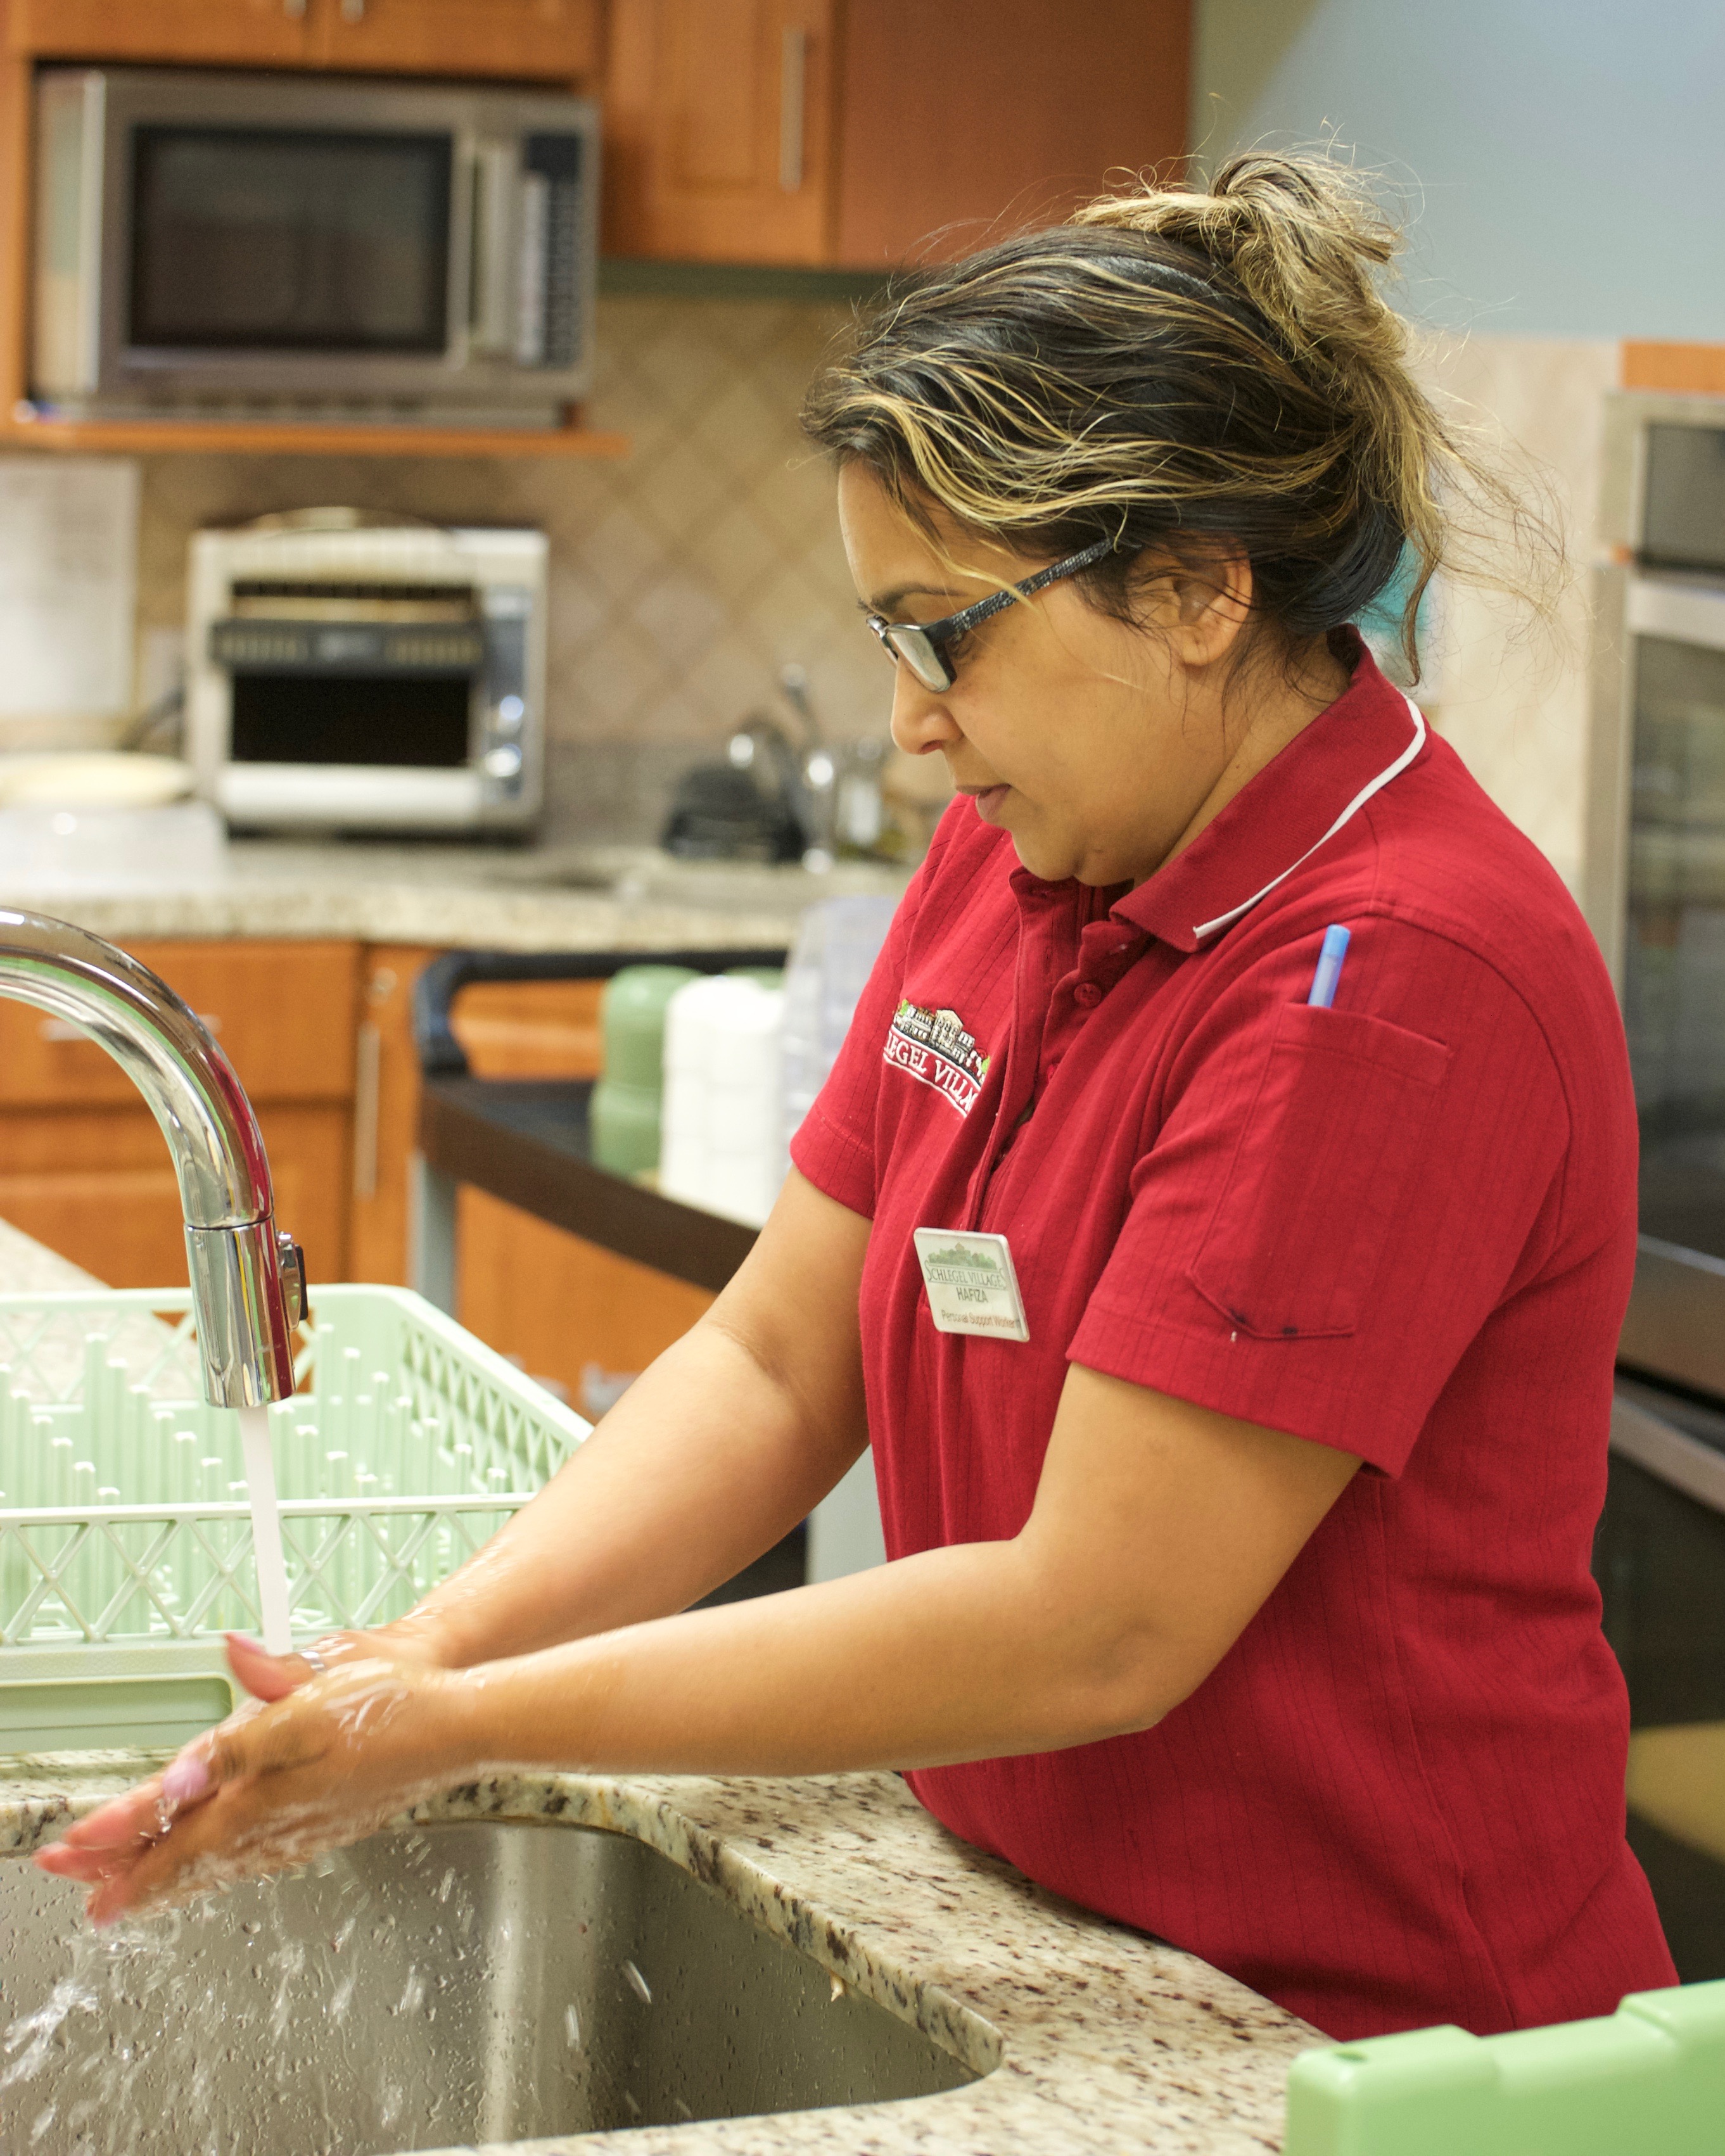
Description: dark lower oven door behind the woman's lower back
xmin=1593 ymin=1380 xmax=1725 ymax=1984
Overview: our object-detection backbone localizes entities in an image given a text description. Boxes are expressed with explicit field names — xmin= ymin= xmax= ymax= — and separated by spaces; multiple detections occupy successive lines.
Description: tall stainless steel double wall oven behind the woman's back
xmin=1585 ymin=395 xmax=1725 ymax=1979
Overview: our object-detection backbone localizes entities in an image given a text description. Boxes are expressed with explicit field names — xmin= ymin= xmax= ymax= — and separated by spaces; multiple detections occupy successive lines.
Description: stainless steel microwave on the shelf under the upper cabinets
xmin=30 ymin=67 xmax=599 ymax=425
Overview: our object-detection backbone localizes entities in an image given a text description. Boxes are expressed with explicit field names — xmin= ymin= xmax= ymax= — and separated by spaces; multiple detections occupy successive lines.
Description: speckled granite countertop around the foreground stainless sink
xmin=0 ymin=1221 xmax=1324 ymax=2156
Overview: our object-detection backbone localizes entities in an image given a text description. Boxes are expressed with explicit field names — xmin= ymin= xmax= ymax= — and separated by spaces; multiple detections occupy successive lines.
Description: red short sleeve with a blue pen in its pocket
xmin=1069 ymin=921 xmax=1570 ymax=1474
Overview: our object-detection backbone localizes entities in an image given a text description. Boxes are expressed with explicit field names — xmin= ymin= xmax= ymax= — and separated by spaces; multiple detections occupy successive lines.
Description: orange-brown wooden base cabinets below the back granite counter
xmin=0 ymin=940 xmax=711 ymax=1404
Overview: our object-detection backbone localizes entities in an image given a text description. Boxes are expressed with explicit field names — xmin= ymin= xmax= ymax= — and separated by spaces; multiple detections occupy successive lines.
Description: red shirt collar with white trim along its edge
xmin=1112 ymin=638 xmax=1425 ymax=951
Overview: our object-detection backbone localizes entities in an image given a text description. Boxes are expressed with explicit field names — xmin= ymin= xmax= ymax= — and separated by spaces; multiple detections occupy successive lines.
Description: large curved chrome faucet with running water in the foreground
xmin=0 ymin=910 xmax=306 ymax=1408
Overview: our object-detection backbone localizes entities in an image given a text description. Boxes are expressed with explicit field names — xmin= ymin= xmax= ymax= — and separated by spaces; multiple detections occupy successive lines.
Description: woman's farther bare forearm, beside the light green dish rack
xmin=390 ymin=1322 xmax=867 ymax=1669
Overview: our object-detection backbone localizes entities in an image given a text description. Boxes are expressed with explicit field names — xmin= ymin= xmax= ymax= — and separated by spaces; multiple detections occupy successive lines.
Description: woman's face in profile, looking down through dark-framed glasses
xmin=839 ymin=464 xmax=1346 ymax=884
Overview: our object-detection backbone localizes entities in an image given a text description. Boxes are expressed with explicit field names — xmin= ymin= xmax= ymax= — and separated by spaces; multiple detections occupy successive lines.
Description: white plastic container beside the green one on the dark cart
xmin=660 ymin=972 xmax=785 ymax=1227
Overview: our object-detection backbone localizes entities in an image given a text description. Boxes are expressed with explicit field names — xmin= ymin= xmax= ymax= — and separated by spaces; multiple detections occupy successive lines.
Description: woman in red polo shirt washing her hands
xmin=41 ymin=157 xmax=1673 ymax=2038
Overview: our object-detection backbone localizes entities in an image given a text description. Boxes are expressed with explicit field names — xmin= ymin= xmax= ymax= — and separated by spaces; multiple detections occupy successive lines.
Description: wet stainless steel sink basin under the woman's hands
xmin=0 ymin=1824 xmax=977 ymax=2156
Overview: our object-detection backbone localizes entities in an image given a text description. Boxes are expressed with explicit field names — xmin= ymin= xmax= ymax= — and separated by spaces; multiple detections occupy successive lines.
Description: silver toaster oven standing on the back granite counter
xmin=186 ymin=509 xmax=545 ymax=834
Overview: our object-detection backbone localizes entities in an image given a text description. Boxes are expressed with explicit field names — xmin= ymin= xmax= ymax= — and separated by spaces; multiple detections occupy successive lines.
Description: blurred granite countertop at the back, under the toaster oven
xmin=0 ymin=839 xmax=908 ymax=951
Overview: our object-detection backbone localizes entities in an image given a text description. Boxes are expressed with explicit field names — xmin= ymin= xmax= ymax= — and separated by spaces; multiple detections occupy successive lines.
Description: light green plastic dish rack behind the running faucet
xmin=0 ymin=1287 xmax=589 ymax=1755
